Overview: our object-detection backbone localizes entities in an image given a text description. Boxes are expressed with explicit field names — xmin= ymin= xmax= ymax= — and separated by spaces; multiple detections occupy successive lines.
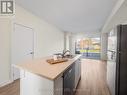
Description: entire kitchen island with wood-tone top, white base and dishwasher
xmin=16 ymin=55 xmax=81 ymax=95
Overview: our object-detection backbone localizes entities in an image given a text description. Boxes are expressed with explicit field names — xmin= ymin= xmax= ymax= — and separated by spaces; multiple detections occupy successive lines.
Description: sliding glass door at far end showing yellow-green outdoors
xmin=75 ymin=38 xmax=101 ymax=59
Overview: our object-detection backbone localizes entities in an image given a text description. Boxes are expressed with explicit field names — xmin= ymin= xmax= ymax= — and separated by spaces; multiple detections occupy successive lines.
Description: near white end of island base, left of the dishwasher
xmin=20 ymin=70 xmax=63 ymax=95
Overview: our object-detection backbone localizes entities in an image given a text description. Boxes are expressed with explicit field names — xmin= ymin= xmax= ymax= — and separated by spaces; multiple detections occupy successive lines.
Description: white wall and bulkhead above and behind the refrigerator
xmin=101 ymin=0 xmax=127 ymax=60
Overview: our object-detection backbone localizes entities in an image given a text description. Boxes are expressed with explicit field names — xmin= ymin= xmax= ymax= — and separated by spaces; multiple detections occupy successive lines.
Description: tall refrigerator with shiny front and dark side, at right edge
xmin=107 ymin=25 xmax=127 ymax=95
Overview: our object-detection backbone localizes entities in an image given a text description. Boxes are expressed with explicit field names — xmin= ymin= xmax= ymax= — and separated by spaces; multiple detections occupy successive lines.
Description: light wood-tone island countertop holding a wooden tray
xmin=15 ymin=55 xmax=81 ymax=80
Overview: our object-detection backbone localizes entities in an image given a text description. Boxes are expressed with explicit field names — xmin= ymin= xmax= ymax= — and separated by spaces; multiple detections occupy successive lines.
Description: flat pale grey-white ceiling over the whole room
xmin=16 ymin=0 xmax=117 ymax=32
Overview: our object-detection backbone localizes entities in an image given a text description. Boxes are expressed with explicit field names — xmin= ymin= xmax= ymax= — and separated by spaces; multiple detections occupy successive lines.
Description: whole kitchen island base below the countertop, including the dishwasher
xmin=20 ymin=59 xmax=81 ymax=95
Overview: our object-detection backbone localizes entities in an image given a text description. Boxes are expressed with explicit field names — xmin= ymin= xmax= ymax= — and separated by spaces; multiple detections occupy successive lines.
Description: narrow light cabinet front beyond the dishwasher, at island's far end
xmin=75 ymin=59 xmax=81 ymax=88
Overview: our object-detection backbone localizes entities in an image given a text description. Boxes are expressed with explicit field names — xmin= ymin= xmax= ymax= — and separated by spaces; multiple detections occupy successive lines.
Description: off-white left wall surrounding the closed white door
xmin=0 ymin=5 xmax=64 ymax=84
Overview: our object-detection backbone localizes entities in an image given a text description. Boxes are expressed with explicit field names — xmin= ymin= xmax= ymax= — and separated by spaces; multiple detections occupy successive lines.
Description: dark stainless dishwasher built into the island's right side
xmin=63 ymin=63 xmax=75 ymax=95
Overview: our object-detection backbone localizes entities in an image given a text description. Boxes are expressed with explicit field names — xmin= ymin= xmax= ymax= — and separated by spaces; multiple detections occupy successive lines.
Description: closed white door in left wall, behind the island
xmin=11 ymin=24 xmax=34 ymax=80
